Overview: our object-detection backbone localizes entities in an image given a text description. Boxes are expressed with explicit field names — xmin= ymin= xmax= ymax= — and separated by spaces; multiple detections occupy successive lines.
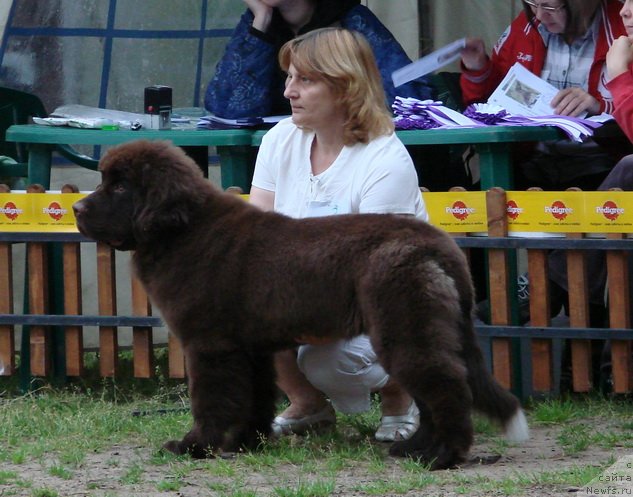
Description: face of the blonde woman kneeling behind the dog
xmin=284 ymin=63 xmax=343 ymax=130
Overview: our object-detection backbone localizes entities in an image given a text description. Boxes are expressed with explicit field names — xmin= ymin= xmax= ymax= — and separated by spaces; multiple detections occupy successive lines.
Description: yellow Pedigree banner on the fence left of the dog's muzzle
xmin=0 ymin=193 xmax=86 ymax=233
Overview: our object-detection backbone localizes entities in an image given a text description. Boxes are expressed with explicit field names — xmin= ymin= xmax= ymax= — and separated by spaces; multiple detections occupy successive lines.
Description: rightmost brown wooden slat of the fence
xmin=607 ymin=233 xmax=631 ymax=393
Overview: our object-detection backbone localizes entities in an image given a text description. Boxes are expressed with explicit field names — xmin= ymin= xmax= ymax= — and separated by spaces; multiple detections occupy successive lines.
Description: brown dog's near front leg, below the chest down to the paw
xmin=164 ymin=344 xmax=264 ymax=458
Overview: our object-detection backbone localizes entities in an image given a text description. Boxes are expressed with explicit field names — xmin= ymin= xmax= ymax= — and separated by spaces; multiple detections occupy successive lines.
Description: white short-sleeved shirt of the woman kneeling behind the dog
xmin=253 ymin=118 xmax=428 ymax=221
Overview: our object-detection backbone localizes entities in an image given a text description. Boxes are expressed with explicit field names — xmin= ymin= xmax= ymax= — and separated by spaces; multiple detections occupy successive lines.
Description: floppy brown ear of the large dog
xmin=134 ymin=144 xmax=203 ymax=241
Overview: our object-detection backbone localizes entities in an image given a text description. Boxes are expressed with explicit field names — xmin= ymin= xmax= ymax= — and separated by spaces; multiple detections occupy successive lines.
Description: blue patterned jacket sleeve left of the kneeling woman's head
xmin=204 ymin=10 xmax=278 ymax=119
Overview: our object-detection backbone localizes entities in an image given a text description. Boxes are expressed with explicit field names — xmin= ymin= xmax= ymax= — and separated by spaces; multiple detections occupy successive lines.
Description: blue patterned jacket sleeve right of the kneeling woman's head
xmin=342 ymin=5 xmax=432 ymax=105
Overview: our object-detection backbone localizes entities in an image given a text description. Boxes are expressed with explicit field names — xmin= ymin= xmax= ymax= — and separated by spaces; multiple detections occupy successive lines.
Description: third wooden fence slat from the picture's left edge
xmin=62 ymin=243 xmax=84 ymax=376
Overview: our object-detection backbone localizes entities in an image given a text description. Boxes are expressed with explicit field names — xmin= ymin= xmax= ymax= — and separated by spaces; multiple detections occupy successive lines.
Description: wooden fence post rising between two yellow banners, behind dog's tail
xmin=486 ymin=188 xmax=512 ymax=389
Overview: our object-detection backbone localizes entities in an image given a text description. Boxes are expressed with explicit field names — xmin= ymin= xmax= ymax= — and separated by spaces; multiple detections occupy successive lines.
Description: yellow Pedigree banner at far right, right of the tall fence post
xmin=506 ymin=191 xmax=633 ymax=233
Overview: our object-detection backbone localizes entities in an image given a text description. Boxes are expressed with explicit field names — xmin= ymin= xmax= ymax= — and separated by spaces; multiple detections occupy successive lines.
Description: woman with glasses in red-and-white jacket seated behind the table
xmin=461 ymin=0 xmax=626 ymax=190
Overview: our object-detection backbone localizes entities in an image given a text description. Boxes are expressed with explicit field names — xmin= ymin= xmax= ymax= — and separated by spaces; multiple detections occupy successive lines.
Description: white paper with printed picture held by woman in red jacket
xmin=488 ymin=62 xmax=558 ymax=116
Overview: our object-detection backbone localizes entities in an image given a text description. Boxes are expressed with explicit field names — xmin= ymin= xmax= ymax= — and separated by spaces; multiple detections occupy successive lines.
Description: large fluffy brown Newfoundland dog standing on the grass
xmin=74 ymin=141 xmax=528 ymax=469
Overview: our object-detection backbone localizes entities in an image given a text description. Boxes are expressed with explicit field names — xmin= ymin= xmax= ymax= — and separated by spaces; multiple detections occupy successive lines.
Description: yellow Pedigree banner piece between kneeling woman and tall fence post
xmin=422 ymin=192 xmax=488 ymax=233
